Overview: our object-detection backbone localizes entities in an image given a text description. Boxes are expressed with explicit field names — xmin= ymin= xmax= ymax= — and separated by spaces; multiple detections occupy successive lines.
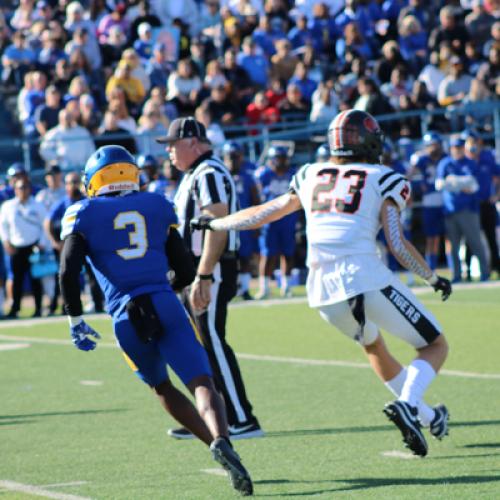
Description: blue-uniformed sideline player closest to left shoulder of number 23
xmin=255 ymin=146 xmax=298 ymax=298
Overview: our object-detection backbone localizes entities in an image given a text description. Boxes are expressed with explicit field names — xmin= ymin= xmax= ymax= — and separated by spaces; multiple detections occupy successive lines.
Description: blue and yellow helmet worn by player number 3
xmin=83 ymin=146 xmax=139 ymax=197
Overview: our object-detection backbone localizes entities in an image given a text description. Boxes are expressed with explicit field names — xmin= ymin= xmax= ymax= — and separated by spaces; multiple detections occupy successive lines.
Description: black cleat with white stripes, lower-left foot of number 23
xmin=384 ymin=401 xmax=427 ymax=457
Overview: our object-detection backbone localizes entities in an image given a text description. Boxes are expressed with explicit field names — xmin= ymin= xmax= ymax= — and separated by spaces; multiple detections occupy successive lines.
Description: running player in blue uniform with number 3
xmin=60 ymin=146 xmax=252 ymax=494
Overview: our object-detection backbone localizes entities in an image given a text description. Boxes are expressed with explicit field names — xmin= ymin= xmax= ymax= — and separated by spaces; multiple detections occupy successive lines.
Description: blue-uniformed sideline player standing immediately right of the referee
xmin=222 ymin=141 xmax=260 ymax=300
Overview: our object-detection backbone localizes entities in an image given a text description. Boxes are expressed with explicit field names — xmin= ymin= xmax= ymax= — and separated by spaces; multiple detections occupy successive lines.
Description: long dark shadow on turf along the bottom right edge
xmin=256 ymin=475 xmax=500 ymax=497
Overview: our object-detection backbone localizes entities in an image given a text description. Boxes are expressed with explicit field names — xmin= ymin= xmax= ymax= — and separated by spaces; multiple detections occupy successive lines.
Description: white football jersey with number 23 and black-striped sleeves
xmin=290 ymin=162 xmax=410 ymax=267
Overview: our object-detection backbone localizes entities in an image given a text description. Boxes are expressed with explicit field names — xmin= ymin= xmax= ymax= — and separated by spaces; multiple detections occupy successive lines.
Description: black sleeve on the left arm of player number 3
xmin=59 ymin=233 xmax=87 ymax=316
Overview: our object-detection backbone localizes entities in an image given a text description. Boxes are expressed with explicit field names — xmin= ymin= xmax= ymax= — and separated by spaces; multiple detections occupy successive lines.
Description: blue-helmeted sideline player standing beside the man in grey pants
xmin=409 ymin=132 xmax=445 ymax=271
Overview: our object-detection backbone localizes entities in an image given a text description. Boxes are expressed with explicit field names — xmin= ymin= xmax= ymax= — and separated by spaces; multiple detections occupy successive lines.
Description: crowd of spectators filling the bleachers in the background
xmin=0 ymin=0 xmax=500 ymax=316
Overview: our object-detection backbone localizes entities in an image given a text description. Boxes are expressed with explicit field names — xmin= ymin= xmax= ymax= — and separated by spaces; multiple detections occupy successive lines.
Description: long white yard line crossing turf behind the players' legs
xmin=0 ymin=335 xmax=500 ymax=380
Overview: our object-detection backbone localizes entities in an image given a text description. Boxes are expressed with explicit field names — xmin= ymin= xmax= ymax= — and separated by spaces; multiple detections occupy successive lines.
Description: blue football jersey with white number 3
xmin=61 ymin=192 xmax=177 ymax=315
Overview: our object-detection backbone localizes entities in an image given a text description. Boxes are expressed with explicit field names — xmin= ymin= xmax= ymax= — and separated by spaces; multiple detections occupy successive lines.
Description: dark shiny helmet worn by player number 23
xmin=328 ymin=109 xmax=384 ymax=163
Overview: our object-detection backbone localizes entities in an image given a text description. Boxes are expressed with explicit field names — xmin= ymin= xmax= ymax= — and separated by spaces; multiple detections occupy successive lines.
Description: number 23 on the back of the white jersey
xmin=311 ymin=168 xmax=366 ymax=214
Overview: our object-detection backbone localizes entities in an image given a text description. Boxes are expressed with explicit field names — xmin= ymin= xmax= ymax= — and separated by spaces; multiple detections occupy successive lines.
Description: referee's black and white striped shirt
xmin=174 ymin=151 xmax=239 ymax=257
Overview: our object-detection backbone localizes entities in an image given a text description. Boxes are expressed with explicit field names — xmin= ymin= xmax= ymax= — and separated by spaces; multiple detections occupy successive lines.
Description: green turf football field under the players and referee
xmin=0 ymin=283 xmax=500 ymax=500
